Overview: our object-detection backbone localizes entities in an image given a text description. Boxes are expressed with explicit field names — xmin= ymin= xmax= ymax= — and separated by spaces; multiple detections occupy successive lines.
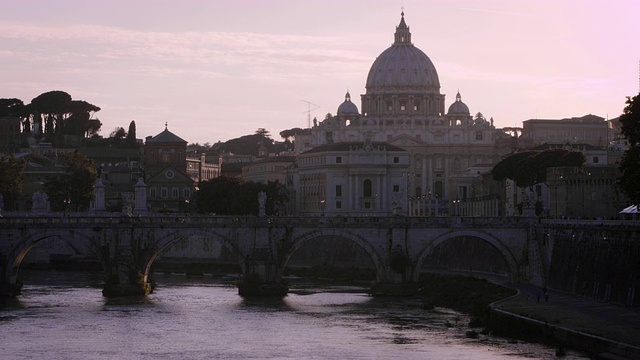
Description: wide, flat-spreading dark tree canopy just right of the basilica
xmin=491 ymin=149 xmax=585 ymax=187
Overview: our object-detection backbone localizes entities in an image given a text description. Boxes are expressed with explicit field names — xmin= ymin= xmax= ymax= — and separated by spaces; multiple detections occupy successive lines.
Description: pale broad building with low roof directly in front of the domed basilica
xmin=290 ymin=141 xmax=409 ymax=215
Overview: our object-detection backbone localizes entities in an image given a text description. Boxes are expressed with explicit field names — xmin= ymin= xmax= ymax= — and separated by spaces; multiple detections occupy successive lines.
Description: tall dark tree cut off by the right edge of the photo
xmin=618 ymin=94 xmax=640 ymax=206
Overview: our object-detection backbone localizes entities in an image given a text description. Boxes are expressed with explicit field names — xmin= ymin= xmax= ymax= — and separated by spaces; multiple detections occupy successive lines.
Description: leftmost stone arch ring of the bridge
xmin=4 ymin=229 xmax=104 ymax=284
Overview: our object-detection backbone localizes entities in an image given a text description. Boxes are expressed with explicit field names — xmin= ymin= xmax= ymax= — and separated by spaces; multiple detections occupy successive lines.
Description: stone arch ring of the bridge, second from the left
xmin=141 ymin=228 xmax=244 ymax=282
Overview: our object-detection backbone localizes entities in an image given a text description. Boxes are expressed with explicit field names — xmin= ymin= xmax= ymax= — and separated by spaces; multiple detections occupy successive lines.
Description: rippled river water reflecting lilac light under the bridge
xmin=0 ymin=271 xmax=586 ymax=360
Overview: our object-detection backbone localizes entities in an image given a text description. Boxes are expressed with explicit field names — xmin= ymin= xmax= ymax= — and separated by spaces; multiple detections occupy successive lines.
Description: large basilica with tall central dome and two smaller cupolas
xmin=296 ymin=13 xmax=505 ymax=214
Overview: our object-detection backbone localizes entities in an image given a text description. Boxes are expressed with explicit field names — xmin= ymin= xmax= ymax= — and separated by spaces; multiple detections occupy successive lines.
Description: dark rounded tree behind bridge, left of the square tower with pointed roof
xmin=45 ymin=150 xmax=98 ymax=211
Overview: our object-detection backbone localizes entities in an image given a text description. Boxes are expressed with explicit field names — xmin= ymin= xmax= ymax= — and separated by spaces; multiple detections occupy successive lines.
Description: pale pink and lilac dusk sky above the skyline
xmin=0 ymin=0 xmax=640 ymax=144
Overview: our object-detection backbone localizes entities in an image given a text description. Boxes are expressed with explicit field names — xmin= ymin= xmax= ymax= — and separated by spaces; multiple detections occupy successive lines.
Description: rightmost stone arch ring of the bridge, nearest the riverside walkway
xmin=413 ymin=229 xmax=519 ymax=281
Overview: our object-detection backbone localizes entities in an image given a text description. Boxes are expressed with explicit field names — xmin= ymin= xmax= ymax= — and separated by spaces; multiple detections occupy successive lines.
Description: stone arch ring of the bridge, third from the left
xmin=288 ymin=229 xmax=386 ymax=281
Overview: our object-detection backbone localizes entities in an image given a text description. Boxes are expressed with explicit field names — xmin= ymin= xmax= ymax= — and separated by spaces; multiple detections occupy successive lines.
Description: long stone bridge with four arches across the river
xmin=0 ymin=214 xmax=550 ymax=296
